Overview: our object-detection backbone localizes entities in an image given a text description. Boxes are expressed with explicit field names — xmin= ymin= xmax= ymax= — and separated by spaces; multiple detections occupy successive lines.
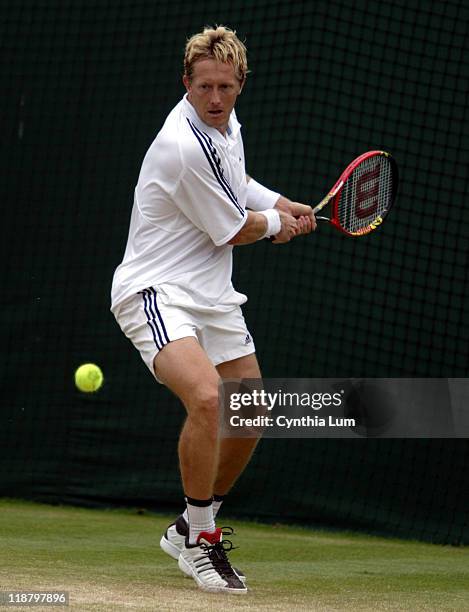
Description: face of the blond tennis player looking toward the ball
xmin=183 ymin=58 xmax=243 ymax=134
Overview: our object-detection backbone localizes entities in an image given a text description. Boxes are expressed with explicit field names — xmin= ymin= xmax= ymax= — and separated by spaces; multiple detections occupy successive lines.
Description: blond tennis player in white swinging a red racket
xmin=111 ymin=26 xmax=316 ymax=593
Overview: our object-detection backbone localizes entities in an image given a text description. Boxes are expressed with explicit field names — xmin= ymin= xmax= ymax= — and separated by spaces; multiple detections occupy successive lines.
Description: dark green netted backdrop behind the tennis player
xmin=0 ymin=0 xmax=469 ymax=543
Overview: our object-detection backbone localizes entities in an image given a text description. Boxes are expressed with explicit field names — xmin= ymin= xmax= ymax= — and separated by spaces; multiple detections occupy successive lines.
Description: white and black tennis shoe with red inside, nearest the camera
xmin=178 ymin=528 xmax=247 ymax=595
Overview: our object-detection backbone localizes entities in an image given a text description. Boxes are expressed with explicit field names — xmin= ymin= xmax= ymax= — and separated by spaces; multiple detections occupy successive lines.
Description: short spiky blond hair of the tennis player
xmin=184 ymin=25 xmax=249 ymax=82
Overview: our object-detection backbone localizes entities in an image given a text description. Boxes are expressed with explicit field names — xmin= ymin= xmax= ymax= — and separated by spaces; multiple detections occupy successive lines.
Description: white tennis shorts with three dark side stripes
xmin=114 ymin=287 xmax=256 ymax=382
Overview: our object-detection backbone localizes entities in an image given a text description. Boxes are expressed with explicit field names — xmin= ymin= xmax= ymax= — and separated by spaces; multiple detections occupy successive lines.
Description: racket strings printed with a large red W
xmin=337 ymin=155 xmax=393 ymax=234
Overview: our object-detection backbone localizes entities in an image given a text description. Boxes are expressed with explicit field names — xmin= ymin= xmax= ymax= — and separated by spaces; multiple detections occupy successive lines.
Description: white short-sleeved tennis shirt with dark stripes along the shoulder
xmin=111 ymin=94 xmax=247 ymax=312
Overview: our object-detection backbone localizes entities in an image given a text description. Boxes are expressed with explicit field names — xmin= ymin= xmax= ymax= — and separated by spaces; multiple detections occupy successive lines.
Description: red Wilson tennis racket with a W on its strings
xmin=313 ymin=151 xmax=399 ymax=236
